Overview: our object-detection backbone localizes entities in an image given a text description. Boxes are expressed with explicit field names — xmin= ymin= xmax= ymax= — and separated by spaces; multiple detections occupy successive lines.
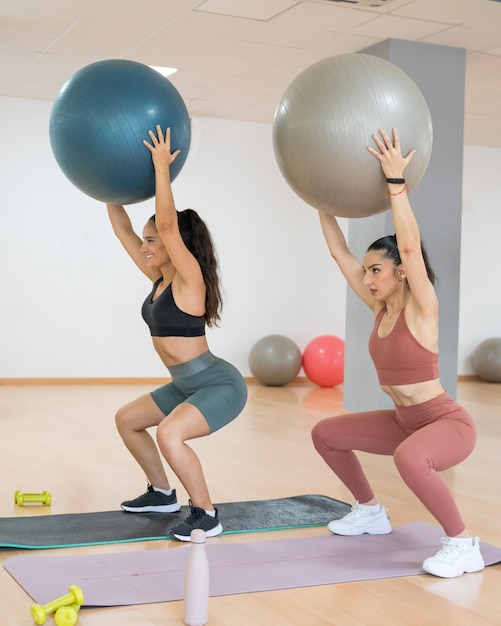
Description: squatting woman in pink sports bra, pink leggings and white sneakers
xmin=312 ymin=129 xmax=484 ymax=578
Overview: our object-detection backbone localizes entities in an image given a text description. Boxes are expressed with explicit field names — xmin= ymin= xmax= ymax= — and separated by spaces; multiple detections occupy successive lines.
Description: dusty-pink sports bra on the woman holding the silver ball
xmin=369 ymin=308 xmax=439 ymax=385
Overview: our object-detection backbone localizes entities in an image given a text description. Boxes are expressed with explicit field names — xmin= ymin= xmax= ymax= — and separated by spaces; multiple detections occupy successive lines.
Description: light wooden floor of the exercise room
xmin=0 ymin=381 xmax=501 ymax=626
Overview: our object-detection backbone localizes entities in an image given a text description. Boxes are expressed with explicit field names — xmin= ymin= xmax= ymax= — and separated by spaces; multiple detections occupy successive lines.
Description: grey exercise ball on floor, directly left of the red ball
xmin=249 ymin=335 xmax=302 ymax=387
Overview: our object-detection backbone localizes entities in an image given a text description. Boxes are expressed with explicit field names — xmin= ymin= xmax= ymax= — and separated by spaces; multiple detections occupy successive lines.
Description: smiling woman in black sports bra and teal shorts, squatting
xmin=107 ymin=126 xmax=247 ymax=541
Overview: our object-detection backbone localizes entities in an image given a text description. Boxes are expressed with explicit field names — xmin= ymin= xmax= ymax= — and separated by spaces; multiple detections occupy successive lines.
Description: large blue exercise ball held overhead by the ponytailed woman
xmin=49 ymin=59 xmax=191 ymax=204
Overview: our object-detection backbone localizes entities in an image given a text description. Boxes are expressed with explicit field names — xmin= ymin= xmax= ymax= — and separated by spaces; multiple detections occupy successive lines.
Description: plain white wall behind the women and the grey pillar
xmin=0 ymin=98 xmax=501 ymax=378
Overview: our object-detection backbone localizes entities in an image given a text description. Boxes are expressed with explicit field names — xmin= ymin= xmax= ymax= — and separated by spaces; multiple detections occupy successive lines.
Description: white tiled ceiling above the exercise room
xmin=0 ymin=0 xmax=501 ymax=147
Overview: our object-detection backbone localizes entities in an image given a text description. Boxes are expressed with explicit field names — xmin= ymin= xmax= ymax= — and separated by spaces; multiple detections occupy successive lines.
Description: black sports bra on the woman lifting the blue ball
xmin=141 ymin=278 xmax=205 ymax=337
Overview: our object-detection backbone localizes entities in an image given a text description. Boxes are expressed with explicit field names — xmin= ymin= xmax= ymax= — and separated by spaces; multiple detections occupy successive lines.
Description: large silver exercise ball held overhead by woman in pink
xmin=273 ymin=53 xmax=433 ymax=217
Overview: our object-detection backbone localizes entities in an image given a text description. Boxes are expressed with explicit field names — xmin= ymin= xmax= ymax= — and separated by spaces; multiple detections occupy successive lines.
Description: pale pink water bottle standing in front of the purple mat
xmin=184 ymin=528 xmax=209 ymax=626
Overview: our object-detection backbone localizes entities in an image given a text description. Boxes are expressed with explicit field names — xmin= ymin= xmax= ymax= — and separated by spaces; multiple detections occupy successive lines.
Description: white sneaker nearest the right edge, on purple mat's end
xmin=423 ymin=537 xmax=485 ymax=578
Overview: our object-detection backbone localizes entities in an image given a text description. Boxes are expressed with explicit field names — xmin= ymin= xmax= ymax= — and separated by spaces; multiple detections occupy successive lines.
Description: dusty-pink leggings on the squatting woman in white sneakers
xmin=312 ymin=393 xmax=476 ymax=537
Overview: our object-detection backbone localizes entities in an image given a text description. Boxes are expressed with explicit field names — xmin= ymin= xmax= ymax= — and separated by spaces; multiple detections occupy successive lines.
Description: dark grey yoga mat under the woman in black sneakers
xmin=0 ymin=495 xmax=351 ymax=549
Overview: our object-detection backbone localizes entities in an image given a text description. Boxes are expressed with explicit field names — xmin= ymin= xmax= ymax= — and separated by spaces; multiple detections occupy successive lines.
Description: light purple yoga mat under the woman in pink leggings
xmin=4 ymin=522 xmax=501 ymax=606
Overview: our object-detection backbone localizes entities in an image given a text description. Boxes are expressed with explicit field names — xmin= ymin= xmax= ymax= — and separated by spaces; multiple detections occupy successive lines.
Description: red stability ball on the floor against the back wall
xmin=303 ymin=335 xmax=344 ymax=387
